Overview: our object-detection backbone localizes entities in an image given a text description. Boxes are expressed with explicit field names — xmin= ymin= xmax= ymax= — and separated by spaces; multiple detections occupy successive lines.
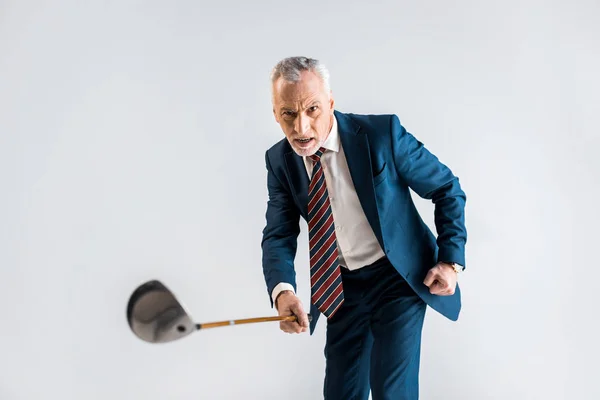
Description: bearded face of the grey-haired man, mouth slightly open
xmin=273 ymin=71 xmax=334 ymax=156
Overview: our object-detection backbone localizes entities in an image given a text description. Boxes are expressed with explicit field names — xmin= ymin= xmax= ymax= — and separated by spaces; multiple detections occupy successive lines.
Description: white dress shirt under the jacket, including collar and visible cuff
xmin=272 ymin=117 xmax=385 ymax=301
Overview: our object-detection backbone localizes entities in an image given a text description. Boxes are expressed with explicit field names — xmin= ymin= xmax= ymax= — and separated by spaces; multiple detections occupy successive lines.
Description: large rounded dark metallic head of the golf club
xmin=127 ymin=280 xmax=196 ymax=343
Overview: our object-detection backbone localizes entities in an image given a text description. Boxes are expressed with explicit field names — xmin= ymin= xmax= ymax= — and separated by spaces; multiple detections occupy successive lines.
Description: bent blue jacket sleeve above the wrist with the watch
xmin=391 ymin=115 xmax=467 ymax=267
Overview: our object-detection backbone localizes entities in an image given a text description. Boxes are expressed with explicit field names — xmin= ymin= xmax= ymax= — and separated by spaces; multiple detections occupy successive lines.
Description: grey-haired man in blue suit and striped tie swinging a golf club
xmin=262 ymin=57 xmax=466 ymax=400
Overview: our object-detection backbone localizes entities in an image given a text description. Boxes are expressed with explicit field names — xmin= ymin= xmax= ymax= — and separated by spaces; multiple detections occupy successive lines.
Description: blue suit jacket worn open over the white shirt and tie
xmin=262 ymin=110 xmax=467 ymax=334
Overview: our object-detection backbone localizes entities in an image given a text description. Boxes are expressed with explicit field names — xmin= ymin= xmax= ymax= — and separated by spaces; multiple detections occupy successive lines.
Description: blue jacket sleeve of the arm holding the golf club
xmin=261 ymin=152 xmax=300 ymax=307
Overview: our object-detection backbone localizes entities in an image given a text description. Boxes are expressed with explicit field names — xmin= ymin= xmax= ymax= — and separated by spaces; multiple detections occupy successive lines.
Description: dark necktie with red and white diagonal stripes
xmin=308 ymin=147 xmax=344 ymax=318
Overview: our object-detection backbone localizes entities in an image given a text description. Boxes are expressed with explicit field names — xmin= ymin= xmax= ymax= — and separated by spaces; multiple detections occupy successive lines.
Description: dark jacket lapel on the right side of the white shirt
xmin=335 ymin=111 xmax=383 ymax=243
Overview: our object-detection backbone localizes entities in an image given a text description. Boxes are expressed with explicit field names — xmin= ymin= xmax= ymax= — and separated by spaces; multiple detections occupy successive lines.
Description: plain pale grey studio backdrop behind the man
xmin=0 ymin=0 xmax=600 ymax=400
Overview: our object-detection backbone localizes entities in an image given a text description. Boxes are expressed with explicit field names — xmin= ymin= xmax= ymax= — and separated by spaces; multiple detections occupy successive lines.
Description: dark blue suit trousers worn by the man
xmin=323 ymin=258 xmax=426 ymax=400
